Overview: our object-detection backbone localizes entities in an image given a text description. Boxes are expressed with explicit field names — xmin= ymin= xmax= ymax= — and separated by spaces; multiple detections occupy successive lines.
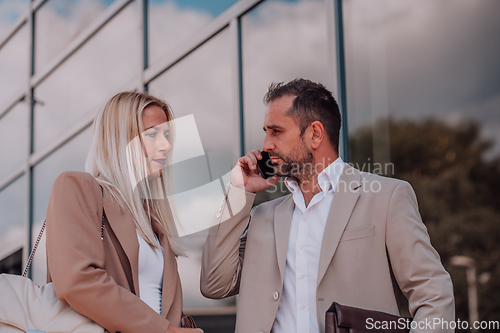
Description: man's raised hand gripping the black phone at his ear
xmin=231 ymin=150 xmax=279 ymax=193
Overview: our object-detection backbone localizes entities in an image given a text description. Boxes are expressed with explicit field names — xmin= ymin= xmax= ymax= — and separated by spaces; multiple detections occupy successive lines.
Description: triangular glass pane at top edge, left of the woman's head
xmin=35 ymin=0 xmax=114 ymax=71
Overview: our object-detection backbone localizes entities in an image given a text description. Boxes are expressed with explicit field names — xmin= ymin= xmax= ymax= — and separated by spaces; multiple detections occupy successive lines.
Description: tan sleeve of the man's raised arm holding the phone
xmin=200 ymin=185 xmax=255 ymax=299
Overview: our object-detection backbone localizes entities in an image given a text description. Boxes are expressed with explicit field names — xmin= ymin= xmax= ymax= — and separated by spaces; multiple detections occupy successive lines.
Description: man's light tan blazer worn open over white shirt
xmin=201 ymin=165 xmax=455 ymax=333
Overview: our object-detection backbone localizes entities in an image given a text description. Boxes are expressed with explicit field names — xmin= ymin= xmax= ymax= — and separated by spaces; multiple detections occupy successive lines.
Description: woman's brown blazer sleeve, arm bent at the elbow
xmin=47 ymin=172 xmax=169 ymax=333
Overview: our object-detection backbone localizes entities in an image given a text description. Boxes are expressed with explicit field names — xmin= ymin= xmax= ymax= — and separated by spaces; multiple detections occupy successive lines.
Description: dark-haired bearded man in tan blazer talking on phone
xmin=201 ymin=79 xmax=455 ymax=333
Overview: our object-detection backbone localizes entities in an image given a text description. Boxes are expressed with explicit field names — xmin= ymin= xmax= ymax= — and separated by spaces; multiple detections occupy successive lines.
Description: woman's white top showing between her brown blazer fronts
xmin=137 ymin=233 xmax=164 ymax=313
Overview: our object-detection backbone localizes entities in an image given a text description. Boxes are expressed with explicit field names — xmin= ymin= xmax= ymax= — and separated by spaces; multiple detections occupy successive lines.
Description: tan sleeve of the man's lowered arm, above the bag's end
xmin=386 ymin=182 xmax=455 ymax=333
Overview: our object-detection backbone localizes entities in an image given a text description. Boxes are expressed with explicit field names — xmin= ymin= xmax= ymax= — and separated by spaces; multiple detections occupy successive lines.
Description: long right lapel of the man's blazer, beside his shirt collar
xmin=317 ymin=164 xmax=361 ymax=285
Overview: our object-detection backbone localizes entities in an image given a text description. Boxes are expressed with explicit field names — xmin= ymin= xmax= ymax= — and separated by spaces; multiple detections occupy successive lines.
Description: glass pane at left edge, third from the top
xmin=0 ymin=103 xmax=28 ymax=179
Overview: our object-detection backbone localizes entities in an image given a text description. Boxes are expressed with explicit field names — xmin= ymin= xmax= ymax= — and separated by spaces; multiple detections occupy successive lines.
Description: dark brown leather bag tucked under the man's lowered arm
xmin=325 ymin=302 xmax=411 ymax=333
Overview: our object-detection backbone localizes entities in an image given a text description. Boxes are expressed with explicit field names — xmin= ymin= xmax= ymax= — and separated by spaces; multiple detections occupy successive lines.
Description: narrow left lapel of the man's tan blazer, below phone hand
xmin=274 ymin=195 xmax=295 ymax=281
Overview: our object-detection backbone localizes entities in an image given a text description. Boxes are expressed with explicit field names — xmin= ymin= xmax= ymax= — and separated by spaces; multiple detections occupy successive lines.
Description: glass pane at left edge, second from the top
xmin=0 ymin=25 xmax=29 ymax=108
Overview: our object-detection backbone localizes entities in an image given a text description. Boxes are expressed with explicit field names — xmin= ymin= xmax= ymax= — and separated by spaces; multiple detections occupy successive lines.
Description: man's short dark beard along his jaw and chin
xmin=269 ymin=141 xmax=314 ymax=181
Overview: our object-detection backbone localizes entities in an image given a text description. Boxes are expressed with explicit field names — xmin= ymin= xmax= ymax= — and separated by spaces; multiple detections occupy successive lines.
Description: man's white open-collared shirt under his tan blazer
xmin=273 ymin=157 xmax=344 ymax=333
